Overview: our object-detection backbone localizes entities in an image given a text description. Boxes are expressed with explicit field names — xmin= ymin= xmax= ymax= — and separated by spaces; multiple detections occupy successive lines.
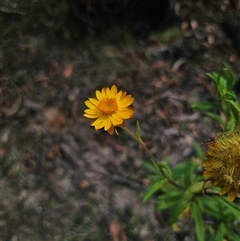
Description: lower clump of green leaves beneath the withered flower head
xmin=143 ymin=153 xmax=240 ymax=241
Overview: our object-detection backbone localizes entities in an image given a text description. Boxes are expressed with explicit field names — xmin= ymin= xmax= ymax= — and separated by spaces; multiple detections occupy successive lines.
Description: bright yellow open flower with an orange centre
xmin=84 ymin=85 xmax=134 ymax=135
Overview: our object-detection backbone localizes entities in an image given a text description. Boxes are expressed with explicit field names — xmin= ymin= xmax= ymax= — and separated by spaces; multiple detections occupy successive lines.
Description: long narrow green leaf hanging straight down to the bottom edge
xmin=192 ymin=202 xmax=205 ymax=241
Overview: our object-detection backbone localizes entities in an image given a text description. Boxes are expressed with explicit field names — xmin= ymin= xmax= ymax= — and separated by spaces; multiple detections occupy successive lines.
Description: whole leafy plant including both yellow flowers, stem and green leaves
xmin=85 ymin=65 xmax=240 ymax=241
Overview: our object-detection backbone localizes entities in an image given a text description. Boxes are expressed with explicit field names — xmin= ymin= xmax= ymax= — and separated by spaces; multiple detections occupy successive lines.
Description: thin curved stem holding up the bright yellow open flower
xmin=121 ymin=127 xmax=184 ymax=190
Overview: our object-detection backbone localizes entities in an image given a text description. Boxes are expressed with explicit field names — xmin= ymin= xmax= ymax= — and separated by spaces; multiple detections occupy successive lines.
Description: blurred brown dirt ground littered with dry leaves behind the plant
xmin=0 ymin=0 xmax=240 ymax=241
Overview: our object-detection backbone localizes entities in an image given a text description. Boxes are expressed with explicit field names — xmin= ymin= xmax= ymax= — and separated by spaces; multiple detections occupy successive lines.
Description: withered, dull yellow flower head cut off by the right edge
xmin=203 ymin=129 xmax=240 ymax=201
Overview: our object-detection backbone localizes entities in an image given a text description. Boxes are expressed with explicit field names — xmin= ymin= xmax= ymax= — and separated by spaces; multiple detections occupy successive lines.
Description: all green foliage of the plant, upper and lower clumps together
xmin=137 ymin=65 xmax=240 ymax=241
